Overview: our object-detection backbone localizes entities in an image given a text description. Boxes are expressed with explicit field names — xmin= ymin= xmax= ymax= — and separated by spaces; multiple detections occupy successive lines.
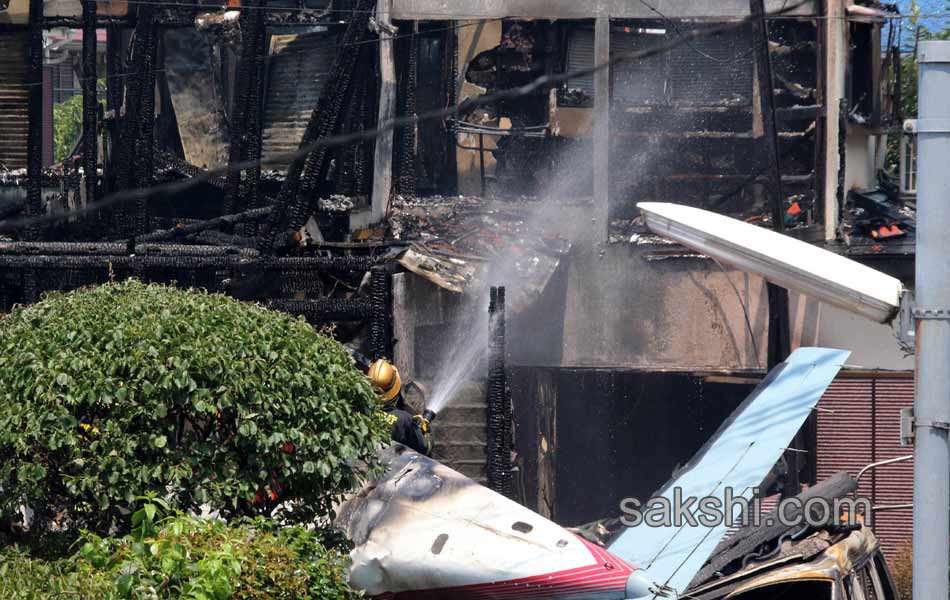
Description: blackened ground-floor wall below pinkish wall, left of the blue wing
xmin=511 ymin=367 xmax=755 ymax=526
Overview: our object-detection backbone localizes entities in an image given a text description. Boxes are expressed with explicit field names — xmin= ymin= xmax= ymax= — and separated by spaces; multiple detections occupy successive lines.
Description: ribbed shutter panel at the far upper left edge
xmin=0 ymin=32 xmax=29 ymax=169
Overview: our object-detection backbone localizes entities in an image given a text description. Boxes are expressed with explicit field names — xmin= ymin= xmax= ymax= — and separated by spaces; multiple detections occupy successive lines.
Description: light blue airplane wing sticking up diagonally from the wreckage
xmin=608 ymin=348 xmax=850 ymax=599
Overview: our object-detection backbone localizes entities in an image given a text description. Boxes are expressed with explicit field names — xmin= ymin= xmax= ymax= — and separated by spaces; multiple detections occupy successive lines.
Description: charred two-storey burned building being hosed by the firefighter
xmin=0 ymin=0 xmax=913 ymax=564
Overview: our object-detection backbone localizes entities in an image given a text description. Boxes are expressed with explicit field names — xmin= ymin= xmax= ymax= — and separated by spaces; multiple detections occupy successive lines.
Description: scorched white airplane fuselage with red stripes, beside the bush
xmin=337 ymin=446 xmax=648 ymax=600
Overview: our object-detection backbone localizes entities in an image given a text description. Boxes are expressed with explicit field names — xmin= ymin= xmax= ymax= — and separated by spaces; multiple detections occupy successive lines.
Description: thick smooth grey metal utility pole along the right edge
xmin=913 ymin=42 xmax=950 ymax=600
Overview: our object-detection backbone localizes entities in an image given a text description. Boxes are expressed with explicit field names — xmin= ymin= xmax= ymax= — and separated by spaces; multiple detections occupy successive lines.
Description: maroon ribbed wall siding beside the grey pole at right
xmin=817 ymin=377 xmax=914 ymax=557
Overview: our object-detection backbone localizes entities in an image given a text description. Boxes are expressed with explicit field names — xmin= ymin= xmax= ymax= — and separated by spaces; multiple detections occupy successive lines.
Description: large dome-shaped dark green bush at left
xmin=0 ymin=281 xmax=388 ymax=532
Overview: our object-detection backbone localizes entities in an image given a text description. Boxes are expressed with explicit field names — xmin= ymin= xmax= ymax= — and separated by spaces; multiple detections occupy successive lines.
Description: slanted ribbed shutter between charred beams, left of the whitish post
xmin=262 ymin=32 xmax=337 ymax=166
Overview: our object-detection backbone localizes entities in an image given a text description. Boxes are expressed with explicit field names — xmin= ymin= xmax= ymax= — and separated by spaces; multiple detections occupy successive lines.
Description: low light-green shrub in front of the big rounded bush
xmin=0 ymin=500 xmax=361 ymax=600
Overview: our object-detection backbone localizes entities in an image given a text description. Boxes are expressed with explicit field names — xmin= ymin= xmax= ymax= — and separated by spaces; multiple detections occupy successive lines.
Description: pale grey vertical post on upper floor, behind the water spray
xmin=594 ymin=14 xmax=611 ymax=243
